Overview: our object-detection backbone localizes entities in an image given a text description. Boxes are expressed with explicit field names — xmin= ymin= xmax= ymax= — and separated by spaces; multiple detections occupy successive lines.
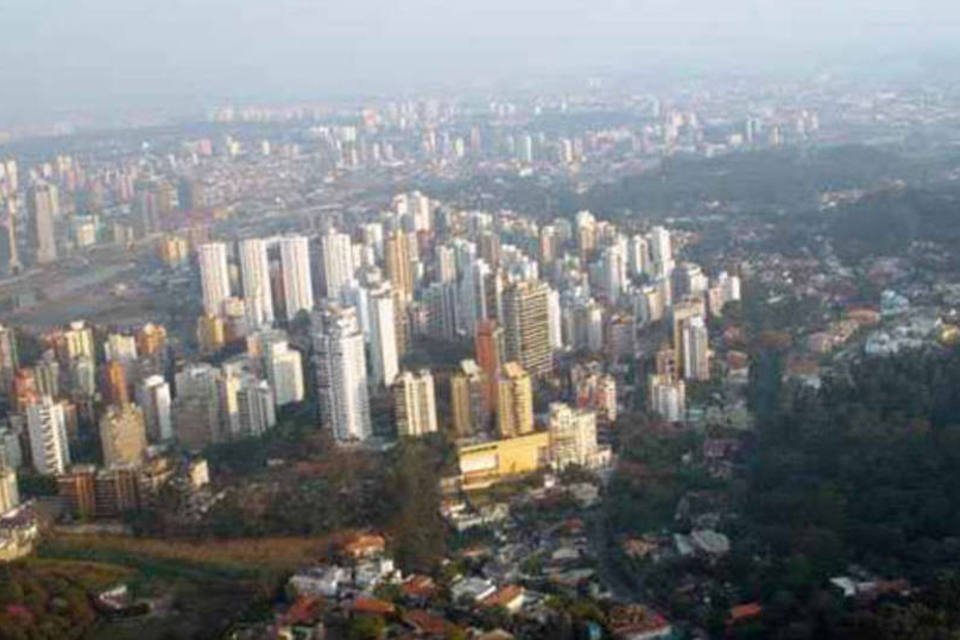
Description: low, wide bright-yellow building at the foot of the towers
xmin=457 ymin=431 xmax=550 ymax=490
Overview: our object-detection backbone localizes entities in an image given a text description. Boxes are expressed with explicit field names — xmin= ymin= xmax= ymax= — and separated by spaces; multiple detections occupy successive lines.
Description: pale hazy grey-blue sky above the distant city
xmin=0 ymin=0 xmax=960 ymax=121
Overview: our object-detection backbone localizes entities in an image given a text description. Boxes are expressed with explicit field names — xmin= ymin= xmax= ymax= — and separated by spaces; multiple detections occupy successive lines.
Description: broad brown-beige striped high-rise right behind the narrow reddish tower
xmin=503 ymin=280 xmax=553 ymax=376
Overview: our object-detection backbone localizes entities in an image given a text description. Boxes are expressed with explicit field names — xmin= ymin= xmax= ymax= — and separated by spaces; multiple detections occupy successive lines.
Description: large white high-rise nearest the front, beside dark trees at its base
xmin=311 ymin=305 xmax=373 ymax=442
